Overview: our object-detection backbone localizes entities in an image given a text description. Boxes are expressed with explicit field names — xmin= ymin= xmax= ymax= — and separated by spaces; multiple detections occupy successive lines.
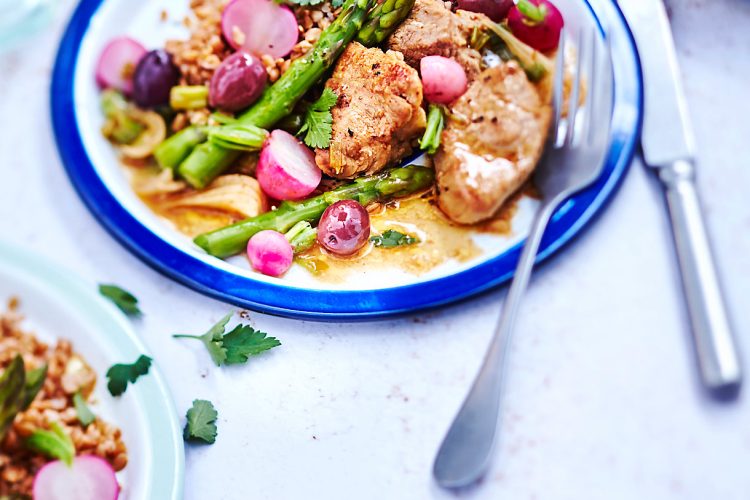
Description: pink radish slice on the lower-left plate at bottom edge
xmin=34 ymin=455 xmax=120 ymax=500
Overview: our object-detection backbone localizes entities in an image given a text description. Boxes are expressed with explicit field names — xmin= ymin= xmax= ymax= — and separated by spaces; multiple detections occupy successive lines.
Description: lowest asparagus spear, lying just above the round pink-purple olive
xmin=194 ymin=165 xmax=435 ymax=258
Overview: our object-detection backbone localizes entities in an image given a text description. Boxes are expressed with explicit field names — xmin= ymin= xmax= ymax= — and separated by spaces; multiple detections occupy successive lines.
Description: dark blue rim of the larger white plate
xmin=50 ymin=0 xmax=643 ymax=321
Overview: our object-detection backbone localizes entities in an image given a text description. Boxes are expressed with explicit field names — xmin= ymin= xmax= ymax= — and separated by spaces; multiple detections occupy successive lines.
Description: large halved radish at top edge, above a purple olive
xmin=221 ymin=0 xmax=299 ymax=58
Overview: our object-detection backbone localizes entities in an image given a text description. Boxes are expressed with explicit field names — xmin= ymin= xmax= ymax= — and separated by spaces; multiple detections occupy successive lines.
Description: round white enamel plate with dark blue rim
xmin=51 ymin=0 xmax=642 ymax=320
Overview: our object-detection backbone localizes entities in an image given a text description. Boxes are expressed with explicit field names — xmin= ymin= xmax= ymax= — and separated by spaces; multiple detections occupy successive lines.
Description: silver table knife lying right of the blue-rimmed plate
xmin=619 ymin=0 xmax=742 ymax=396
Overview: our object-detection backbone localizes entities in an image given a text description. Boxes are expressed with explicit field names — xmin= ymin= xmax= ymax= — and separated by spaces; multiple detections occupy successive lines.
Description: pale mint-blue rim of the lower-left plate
xmin=0 ymin=241 xmax=185 ymax=500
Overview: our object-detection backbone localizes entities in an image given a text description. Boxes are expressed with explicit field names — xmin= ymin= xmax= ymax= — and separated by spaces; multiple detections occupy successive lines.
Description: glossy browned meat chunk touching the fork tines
xmin=435 ymin=62 xmax=552 ymax=224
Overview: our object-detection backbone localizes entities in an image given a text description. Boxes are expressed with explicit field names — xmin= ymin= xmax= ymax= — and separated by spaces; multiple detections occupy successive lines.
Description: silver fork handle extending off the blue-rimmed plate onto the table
xmin=432 ymin=203 xmax=556 ymax=488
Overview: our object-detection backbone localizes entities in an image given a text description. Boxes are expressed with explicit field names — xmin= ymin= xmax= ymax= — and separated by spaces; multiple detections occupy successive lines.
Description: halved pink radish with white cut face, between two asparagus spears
xmin=255 ymin=130 xmax=323 ymax=200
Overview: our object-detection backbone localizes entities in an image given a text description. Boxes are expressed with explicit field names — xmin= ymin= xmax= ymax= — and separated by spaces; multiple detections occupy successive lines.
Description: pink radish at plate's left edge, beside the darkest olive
xmin=96 ymin=36 xmax=146 ymax=95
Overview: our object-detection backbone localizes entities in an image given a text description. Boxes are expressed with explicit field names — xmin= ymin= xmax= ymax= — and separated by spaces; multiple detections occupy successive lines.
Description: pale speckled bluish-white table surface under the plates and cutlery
xmin=0 ymin=0 xmax=750 ymax=500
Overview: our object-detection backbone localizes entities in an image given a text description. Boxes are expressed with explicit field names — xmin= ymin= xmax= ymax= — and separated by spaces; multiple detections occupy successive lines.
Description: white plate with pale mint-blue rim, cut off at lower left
xmin=0 ymin=242 xmax=185 ymax=500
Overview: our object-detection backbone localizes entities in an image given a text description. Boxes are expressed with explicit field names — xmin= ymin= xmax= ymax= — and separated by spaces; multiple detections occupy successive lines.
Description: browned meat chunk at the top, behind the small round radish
xmin=388 ymin=0 xmax=489 ymax=80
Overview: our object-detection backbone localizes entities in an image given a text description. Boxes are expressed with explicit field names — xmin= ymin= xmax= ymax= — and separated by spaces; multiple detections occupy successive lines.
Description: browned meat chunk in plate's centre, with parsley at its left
xmin=315 ymin=42 xmax=425 ymax=179
